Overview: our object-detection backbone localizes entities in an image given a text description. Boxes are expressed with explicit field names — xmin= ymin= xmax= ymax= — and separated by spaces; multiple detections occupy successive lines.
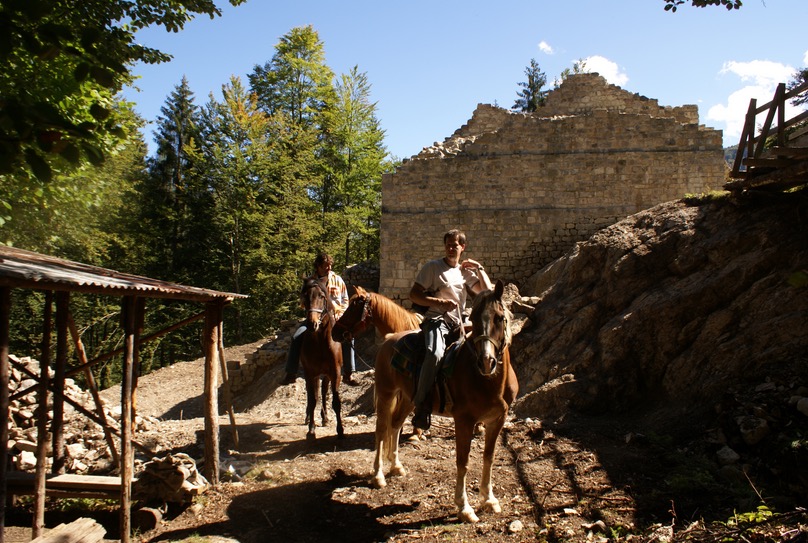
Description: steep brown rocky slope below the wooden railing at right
xmin=514 ymin=194 xmax=808 ymax=417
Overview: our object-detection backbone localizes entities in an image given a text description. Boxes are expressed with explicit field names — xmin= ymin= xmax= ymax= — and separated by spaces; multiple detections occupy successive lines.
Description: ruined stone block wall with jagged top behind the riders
xmin=379 ymin=74 xmax=726 ymax=305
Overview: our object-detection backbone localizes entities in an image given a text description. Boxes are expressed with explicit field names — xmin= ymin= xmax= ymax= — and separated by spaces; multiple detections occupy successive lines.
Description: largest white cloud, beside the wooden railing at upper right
xmin=707 ymin=59 xmax=808 ymax=146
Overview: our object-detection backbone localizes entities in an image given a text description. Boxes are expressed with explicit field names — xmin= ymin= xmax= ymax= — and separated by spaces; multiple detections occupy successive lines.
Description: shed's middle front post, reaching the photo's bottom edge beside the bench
xmin=120 ymin=296 xmax=137 ymax=543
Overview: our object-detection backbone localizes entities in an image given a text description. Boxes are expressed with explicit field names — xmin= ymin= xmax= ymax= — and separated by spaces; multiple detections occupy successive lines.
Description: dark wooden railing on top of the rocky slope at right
xmin=730 ymin=81 xmax=808 ymax=179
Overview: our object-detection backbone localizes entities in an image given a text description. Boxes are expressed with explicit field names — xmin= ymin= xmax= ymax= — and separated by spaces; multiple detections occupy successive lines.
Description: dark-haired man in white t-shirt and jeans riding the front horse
xmin=410 ymin=230 xmax=493 ymax=430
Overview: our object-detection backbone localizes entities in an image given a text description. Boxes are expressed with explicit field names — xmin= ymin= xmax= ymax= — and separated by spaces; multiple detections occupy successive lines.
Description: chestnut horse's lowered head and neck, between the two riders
xmin=333 ymin=287 xmax=421 ymax=341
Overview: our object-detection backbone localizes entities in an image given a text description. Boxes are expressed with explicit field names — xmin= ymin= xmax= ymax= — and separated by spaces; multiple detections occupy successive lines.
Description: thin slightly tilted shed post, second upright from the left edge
xmin=31 ymin=290 xmax=53 ymax=539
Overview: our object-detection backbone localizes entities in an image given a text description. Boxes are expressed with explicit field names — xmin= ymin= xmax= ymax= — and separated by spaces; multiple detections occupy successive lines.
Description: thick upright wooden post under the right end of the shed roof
xmin=202 ymin=302 xmax=222 ymax=485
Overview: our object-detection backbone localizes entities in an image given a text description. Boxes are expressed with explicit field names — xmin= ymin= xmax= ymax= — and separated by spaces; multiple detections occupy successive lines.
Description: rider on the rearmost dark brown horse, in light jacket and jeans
xmin=281 ymin=253 xmax=357 ymax=386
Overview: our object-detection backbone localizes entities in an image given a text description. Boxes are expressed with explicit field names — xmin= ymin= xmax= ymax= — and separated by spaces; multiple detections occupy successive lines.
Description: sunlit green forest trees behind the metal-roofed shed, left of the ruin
xmin=0 ymin=22 xmax=393 ymax=374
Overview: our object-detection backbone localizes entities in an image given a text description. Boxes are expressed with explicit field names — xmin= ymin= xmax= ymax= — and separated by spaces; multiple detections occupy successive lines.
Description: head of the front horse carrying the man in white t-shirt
xmin=466 ymin=281 xmax=511 ymax=375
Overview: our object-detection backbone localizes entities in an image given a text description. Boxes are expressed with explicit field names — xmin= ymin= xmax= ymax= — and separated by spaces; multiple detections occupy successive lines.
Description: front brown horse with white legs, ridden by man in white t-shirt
xmin=371 ymin=281 xmax=518 ymax=522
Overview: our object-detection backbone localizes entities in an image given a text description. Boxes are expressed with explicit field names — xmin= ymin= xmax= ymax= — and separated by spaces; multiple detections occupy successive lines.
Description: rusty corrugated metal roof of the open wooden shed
xmin=0 ymin=246 xmax=248 ymax=302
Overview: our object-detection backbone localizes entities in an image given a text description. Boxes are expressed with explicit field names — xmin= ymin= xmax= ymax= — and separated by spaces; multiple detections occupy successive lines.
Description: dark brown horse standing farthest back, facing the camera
xmin=300 ymin=278 xmax=344 ymax=439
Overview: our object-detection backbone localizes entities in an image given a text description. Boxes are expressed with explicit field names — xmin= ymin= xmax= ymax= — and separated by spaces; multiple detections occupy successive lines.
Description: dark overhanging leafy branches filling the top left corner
xmin=0 ymin=0 xmax=244 ymax=181
